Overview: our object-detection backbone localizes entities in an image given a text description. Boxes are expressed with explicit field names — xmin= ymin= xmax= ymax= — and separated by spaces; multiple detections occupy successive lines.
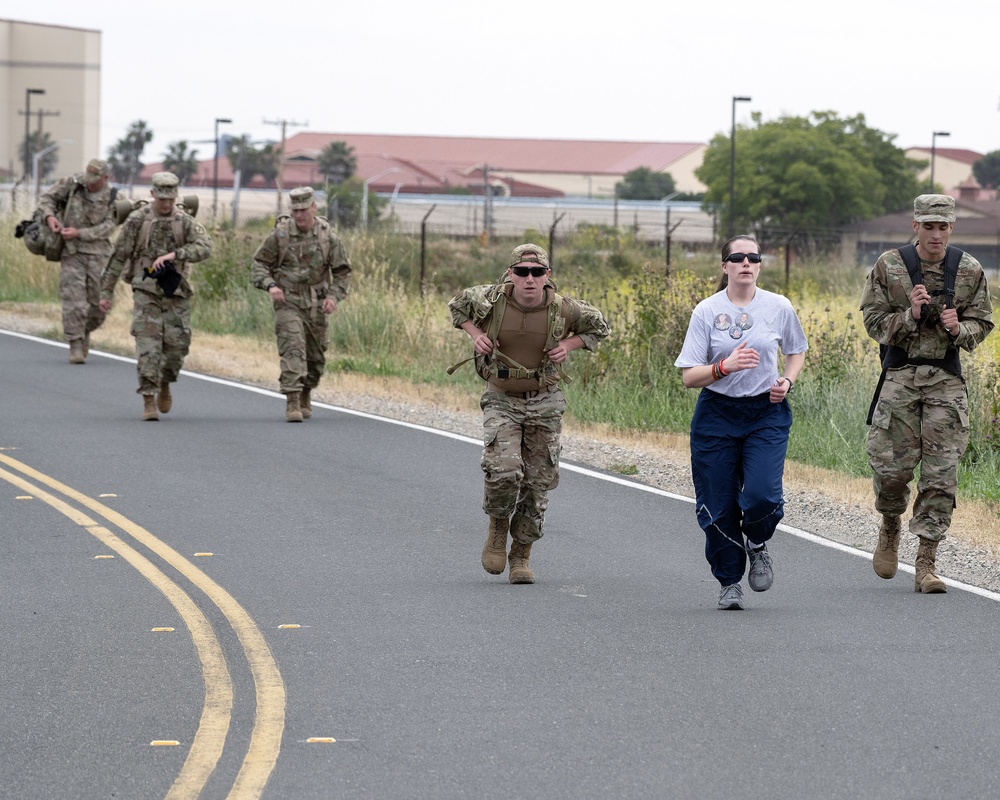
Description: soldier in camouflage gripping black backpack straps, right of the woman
xmin=861 ymin=194 xmax=993 ymax=593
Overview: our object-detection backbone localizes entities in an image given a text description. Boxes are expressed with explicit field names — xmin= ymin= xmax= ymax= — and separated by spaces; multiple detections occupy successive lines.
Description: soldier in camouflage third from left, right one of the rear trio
xmin=251 ymin=186 xmax=351 ymax=422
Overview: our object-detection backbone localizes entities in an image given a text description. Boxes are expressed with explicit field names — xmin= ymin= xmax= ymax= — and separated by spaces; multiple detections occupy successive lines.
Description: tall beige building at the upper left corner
xmin=0 ymin=19 xmax=101 ymax=186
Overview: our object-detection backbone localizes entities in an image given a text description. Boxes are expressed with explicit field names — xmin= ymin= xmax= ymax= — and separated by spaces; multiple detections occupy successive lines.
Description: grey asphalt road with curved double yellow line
xmin=0 ymin=333 xmax=1000 ymax=800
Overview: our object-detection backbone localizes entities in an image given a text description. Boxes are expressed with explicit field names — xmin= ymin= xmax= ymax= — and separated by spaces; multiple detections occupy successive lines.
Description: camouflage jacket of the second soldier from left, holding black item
xmin=101 ymin=206 xmax=212 ymax=300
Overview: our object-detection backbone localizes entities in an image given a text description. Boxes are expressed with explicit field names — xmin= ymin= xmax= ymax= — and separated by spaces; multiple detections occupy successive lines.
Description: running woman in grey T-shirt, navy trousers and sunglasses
xmin=674 ymin=234 xmax=808 ymax=610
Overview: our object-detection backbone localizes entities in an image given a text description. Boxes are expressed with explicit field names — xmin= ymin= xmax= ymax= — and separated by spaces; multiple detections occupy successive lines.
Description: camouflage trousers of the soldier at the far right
xmin=868 ymin=366 xmax=969 ymax=541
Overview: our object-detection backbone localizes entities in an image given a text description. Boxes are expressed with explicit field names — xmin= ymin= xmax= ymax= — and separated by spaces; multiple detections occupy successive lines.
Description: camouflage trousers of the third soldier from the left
xmin=274 ymin=302 xmax=329 ymax=394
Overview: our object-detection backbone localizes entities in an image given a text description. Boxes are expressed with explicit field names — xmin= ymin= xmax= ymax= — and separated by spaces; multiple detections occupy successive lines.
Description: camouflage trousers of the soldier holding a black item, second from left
xmin=132 ymin=289 xmax=191 ymax=394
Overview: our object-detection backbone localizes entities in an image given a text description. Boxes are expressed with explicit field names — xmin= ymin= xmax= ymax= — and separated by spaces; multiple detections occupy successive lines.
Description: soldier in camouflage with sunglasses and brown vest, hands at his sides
xmin=448 ymin=244 xmax=610 ymax=583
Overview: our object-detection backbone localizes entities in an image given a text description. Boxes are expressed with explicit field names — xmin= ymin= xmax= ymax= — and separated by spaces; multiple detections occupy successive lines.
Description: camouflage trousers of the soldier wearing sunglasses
xmin=479 ymin=388 xmax=566 ymax=544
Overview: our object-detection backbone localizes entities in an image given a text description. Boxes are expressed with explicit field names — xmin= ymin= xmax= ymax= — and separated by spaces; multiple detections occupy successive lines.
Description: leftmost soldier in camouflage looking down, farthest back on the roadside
xmin=38 ymin=158 xmax=115 ymax=364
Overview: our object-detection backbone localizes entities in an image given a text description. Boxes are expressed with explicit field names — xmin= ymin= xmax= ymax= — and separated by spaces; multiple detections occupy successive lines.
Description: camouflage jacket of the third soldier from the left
xmin=250 ymin=217 xmax=351 ymax=304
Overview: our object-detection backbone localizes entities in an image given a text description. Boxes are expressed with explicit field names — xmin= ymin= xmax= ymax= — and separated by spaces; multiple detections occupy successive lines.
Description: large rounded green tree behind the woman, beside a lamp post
xmin=695 ymin=111 xmax=921 ymax=239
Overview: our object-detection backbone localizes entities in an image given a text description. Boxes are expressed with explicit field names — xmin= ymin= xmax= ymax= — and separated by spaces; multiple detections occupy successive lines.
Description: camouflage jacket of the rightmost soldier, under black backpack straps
xmin=861 ymin=250 xmax=993 ymax=359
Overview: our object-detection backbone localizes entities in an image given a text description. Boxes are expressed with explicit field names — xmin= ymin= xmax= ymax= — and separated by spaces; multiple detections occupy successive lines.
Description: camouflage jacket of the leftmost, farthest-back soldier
xmin=38 ymin=175 xmax=115 ymax=256
